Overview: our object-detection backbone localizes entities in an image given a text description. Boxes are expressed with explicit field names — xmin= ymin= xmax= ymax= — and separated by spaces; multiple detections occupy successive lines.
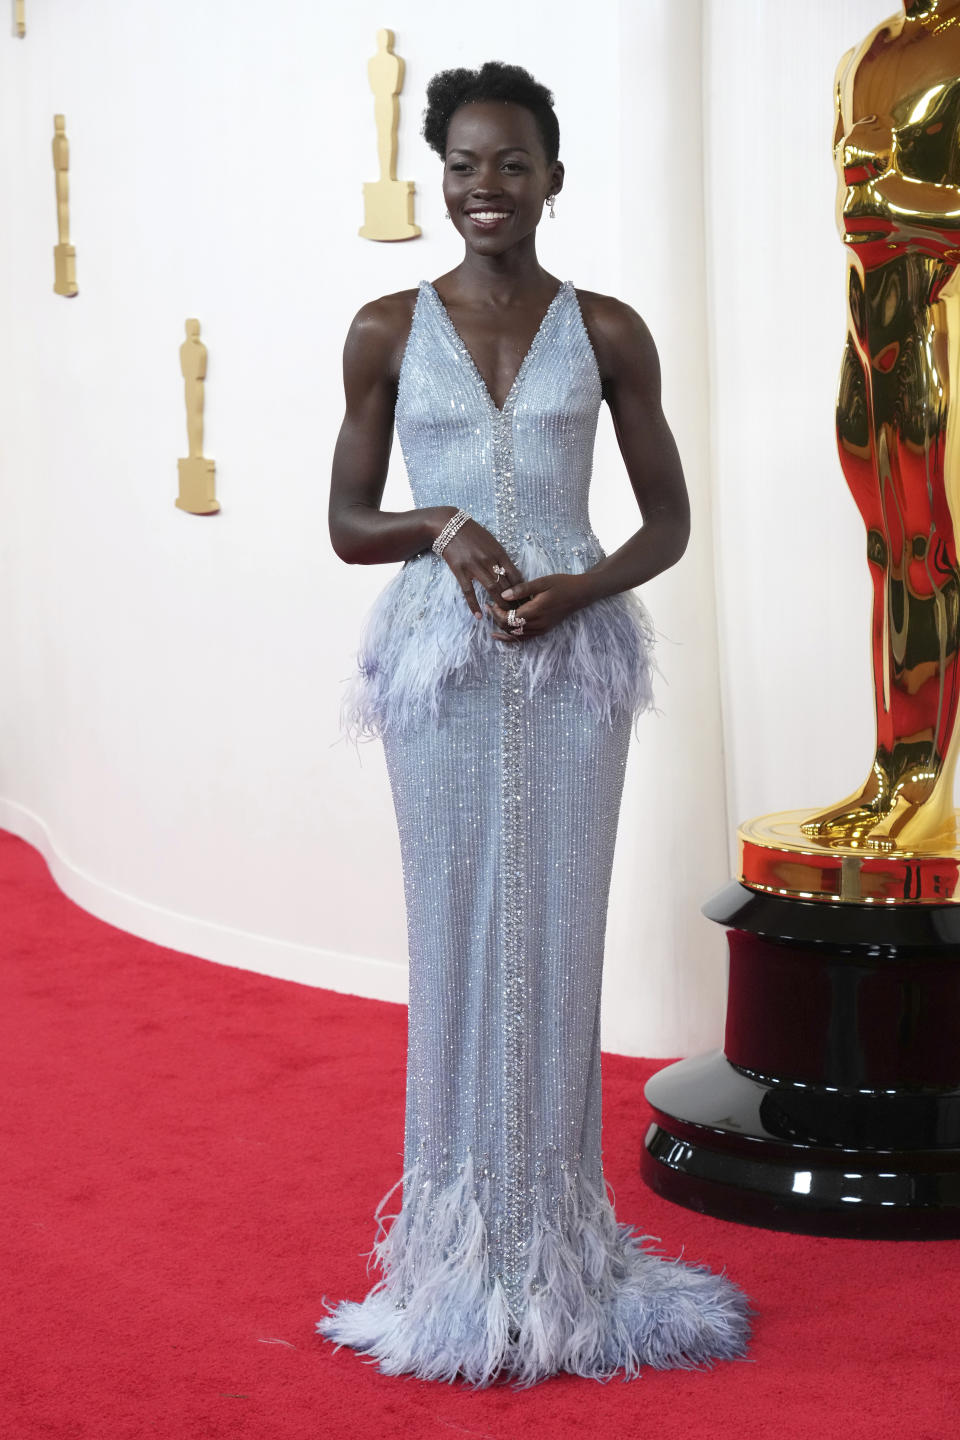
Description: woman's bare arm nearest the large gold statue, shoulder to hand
xmin=492 ymin=291 xmax=689 ymax=635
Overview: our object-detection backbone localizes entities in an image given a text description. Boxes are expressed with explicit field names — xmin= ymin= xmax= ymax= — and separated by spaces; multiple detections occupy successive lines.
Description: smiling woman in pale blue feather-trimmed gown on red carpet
xmin=318 ymin=62 xmax=747 ymax=1385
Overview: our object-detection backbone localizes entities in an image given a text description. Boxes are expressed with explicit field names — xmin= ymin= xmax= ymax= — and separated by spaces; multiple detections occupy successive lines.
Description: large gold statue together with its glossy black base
xmin=643 ymin=0 xmax=960 ymax=1237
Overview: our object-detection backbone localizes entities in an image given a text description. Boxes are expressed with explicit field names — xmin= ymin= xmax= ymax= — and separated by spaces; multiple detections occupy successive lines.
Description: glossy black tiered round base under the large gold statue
xmin=642 ymin=884 xmax=960 ymax=1240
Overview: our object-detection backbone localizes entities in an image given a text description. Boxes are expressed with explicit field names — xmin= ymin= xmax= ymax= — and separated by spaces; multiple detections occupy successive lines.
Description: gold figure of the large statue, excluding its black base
xmin=740 ymin=0 xmax=960 ymax=904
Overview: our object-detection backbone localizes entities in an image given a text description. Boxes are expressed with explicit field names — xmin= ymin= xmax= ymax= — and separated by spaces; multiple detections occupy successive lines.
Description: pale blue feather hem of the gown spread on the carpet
xmin=317 ymin=1156 xmax=751 ymax=1388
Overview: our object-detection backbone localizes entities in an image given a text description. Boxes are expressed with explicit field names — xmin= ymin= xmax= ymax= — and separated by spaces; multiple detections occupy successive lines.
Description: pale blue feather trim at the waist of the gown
xmin=343 ymin=537 xmax=655 ymax=737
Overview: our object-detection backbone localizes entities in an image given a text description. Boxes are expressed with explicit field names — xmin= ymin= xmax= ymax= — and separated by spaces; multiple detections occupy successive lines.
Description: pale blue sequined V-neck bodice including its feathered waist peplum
xmin=345 ymin=279 xmax=653 ymax=734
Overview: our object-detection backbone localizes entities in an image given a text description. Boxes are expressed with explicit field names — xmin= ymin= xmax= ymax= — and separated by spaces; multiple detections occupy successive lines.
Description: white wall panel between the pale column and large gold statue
xmin=705 ymin=0 xmax=895 ymax=846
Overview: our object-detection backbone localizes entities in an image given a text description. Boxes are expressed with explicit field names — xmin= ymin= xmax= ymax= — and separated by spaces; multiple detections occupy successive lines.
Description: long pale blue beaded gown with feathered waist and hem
xmin=317 ymin=281 xmax=748 ymax=1385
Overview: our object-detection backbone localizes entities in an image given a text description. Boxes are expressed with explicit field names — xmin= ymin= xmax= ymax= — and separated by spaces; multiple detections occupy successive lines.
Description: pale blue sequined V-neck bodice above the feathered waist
xmin=396 ymin=279 xmax=602 ymax=549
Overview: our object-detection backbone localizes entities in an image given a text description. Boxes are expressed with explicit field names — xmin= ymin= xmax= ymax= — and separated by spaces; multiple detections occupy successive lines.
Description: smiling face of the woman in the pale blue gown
xmin=443 ymin=101 xmax=563 ymax=255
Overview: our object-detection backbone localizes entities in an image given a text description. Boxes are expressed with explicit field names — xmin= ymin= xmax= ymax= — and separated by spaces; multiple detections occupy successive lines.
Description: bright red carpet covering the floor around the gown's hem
xmin=0 ymin=832 xmax=960 ymax=1440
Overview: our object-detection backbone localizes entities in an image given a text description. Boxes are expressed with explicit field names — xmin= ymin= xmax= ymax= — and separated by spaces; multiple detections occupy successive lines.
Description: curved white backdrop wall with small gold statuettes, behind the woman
xmin=0 ymin=0 xmax=881 ymax=1056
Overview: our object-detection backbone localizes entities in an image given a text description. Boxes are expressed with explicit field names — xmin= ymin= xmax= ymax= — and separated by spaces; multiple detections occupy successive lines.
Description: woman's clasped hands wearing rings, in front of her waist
xmin=443 ymin=520 xmax=593 ymax=644
